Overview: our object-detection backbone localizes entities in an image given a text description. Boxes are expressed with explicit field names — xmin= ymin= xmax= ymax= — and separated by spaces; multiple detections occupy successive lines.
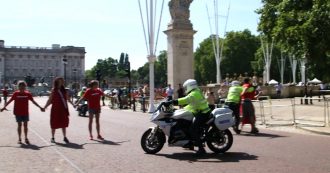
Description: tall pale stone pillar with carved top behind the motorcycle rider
xmin=164 ymin=0 xmax=196 ymax=98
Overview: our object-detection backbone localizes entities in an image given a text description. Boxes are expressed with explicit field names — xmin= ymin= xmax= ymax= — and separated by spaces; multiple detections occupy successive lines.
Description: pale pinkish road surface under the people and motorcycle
xmin=0 ymin=97 xmax=330 ymax=173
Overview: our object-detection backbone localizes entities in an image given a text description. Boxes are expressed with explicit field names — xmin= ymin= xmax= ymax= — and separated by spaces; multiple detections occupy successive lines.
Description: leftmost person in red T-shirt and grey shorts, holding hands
xmin=1 ymin=81 xmax=45 ymax=145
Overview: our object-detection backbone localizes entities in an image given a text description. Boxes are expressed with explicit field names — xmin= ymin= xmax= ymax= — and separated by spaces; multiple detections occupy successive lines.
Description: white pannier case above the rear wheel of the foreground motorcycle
xmin=212 ymin=108 xmax=235 ymax=130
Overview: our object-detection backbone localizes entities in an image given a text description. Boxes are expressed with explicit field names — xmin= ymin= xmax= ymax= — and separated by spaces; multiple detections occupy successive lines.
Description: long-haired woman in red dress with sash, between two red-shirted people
xmin=44 ymin=77 xmax=73 ymax=143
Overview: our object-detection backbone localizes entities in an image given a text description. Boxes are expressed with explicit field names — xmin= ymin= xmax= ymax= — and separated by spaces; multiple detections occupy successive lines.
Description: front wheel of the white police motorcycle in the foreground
xmin=141 ymin=129 xmax=166 ymax=154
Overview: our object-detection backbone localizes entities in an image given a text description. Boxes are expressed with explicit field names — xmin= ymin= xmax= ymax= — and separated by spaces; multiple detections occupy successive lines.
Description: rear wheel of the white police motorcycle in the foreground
xmin=206 ymin=128 xmax=233 ymax=153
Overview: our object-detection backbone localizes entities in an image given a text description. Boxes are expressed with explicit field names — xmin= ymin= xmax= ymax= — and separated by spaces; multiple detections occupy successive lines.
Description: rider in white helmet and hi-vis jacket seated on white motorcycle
xmin=166 ymin=79 xmax=211 ymax=155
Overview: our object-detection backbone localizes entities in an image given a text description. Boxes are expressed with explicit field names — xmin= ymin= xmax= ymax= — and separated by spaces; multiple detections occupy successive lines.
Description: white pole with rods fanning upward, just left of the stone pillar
xmin=138 ymin=0 xmax=164 ymax=112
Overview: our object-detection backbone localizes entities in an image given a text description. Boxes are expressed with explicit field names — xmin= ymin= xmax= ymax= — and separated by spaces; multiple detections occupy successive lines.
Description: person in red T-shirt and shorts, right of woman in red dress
xmin=76 ymin=80 xmax=111 ymax=140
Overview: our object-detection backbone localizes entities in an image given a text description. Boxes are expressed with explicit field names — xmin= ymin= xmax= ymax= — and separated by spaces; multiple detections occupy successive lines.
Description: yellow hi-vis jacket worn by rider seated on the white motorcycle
xmin=178 ymin=89 xmax=210 ymax=115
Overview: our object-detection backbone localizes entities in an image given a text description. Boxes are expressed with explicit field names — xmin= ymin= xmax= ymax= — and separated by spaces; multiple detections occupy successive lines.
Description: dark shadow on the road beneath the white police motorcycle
xmin=156 ymin=152 xmax=258 ymax=162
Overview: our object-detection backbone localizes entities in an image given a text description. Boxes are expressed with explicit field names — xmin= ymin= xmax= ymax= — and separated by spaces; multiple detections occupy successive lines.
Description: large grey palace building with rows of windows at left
xmin=0 ymin=40 xmax=86 ymax=86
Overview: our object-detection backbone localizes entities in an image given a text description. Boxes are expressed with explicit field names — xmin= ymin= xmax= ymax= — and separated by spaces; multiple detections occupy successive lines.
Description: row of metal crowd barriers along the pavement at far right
xmin=253 ymin=96 xmax=330 ymax=127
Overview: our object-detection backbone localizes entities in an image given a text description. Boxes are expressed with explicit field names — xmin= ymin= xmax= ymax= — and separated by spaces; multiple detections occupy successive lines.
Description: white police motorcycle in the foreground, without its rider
xmin=141 ymin=102 xmax=235 ymax=154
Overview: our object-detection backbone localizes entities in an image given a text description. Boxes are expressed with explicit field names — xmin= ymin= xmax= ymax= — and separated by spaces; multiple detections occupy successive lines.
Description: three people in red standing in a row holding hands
xmin=1 ymin=77 xmax=110 ymax=145
